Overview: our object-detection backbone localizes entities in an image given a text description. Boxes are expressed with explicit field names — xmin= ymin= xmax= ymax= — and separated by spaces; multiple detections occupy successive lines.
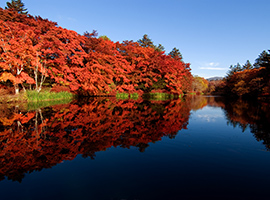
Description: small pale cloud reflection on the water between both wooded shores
xmin=191 ymin=106 xmax=224 ymax=122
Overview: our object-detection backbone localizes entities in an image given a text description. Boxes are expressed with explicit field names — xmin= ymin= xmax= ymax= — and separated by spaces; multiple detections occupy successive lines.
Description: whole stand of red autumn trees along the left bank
xmin=0 ymin=2 xmax=193 ymax=100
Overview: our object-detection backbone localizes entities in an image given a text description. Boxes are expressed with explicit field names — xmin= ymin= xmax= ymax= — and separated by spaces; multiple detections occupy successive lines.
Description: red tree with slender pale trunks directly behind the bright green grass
xmin=35 ymin=27 xmax=86 ymax=91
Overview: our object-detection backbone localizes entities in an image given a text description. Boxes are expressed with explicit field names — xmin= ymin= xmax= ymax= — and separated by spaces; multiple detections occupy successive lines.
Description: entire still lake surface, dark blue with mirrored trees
xmin=0 ymin=96 xmax=270 ymax=200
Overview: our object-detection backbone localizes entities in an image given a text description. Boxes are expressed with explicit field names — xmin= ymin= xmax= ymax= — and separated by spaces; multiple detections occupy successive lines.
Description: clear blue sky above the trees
xmin=0 ymin=0 xmax=270 ymax=78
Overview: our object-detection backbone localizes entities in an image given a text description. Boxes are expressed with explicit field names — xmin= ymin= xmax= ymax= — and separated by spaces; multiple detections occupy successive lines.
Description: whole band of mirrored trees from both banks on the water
xmin=0 ymin=96 xmax=270 ymax=182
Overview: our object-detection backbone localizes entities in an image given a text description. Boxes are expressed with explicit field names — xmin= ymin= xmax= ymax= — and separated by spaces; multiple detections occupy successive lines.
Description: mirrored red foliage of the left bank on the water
xmin=0 ymin=99 xmax=190 ymax=181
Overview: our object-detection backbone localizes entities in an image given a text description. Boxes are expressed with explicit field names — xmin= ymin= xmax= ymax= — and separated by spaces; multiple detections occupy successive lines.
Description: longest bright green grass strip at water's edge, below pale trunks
xmin=26 ymin=90 xmax=74 ymax=102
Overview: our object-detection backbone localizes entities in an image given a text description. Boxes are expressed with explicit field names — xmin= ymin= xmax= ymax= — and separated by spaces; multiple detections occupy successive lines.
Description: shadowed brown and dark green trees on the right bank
xmin=207 ymin=50 xmax=270 ymax=98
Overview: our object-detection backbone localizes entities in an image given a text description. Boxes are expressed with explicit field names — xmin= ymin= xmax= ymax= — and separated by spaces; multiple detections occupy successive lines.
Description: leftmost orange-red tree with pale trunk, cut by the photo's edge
xmin=0 ymin=21 xmax=35 ymax=94
